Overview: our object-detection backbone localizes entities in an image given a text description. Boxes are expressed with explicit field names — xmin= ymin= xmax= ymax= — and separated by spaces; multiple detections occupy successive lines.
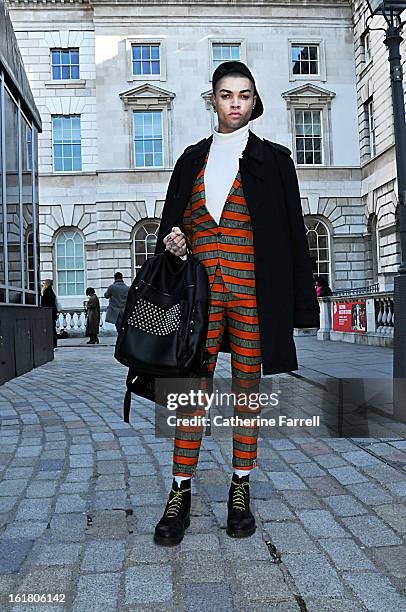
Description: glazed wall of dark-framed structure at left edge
xmin=0 ymin=74 xmax=39 ymax=305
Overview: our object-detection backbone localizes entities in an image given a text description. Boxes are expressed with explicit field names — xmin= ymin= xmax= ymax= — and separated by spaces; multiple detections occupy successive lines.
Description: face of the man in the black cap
xmin=213 ymin=76 xmax=257 ymax=132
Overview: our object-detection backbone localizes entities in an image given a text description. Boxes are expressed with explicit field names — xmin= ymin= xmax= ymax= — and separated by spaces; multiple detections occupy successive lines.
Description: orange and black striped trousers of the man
xmin=172 ymin=265 xmax=261 ymax=476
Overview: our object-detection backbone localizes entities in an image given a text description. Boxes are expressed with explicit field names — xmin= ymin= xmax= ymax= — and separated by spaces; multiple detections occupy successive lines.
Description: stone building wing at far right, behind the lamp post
xmin=351 ymin=0 xmax=406 ymax=290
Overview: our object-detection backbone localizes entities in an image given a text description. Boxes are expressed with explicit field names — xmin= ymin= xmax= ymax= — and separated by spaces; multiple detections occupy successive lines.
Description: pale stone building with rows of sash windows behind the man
xmin=10 ymin=0 xmax=398 ymax=307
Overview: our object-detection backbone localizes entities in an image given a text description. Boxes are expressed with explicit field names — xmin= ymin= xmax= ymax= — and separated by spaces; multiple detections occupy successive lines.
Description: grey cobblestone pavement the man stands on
xmin=0 ymin=339 xmax=406 ymax=612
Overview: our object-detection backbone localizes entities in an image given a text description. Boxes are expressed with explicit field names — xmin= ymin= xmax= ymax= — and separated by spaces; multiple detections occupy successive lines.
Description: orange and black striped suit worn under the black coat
xmin=173 ymin=155 xmax=261 ymax=476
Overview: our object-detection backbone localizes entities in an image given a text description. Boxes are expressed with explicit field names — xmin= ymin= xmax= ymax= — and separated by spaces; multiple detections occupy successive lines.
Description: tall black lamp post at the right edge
xmin=367 ymin=0 xmax=406 ymax=422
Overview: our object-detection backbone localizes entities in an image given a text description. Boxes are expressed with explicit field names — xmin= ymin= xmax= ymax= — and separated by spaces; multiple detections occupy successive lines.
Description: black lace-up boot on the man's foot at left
xmin=154 ymin=478 xmax=191 ymax=546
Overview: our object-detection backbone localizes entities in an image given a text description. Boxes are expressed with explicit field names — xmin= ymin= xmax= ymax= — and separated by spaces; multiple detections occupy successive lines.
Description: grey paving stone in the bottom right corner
xmin=345 ymin=572 xmax=406 ymax=612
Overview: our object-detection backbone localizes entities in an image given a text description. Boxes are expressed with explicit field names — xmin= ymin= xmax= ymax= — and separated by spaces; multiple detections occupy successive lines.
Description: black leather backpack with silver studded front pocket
xmin=114 ymin=250 xmax=209 ymax=422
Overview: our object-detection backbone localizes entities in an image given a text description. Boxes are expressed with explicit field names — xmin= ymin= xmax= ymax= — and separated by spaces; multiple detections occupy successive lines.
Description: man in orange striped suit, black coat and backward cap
xmin=154 ymin=61 xmax=319 ymax=545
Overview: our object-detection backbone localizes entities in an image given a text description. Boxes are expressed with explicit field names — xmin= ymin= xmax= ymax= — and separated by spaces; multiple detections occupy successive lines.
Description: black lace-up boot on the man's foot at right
xmin=226 ymin=474 xmax=257 ymax=538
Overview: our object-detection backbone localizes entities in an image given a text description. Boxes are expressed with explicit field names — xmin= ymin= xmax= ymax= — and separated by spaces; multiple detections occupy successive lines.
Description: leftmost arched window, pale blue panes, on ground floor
xmin=55 ymin=229 xmax=85 ymax=297
